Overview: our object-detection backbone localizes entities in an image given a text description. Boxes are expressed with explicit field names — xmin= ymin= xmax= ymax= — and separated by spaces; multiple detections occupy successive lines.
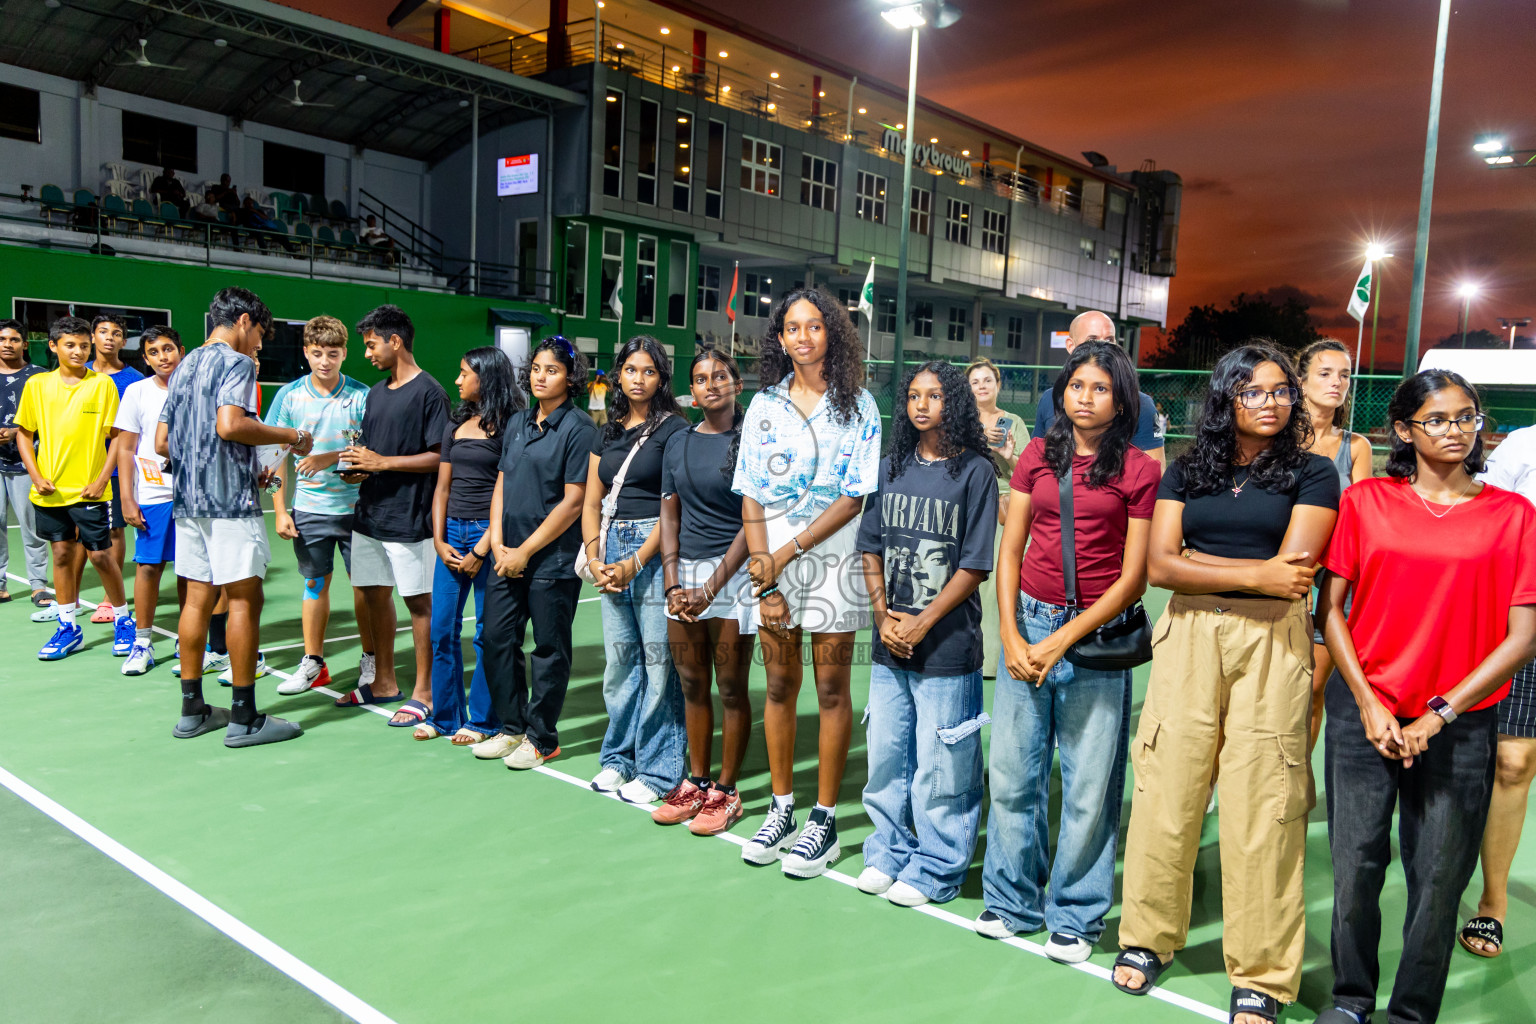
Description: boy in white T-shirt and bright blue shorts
xmin=114 ymin=327 xmax=186 ymax=676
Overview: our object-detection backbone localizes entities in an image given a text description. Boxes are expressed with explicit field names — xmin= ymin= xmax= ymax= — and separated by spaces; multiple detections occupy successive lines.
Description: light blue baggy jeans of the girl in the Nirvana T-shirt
xmin=863 ymin=662 xmax=989 ymax=903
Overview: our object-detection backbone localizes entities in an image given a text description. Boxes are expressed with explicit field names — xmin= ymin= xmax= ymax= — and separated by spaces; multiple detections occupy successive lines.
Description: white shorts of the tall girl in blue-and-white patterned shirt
xmin=753 ymin=507 xmax=871 ymax=633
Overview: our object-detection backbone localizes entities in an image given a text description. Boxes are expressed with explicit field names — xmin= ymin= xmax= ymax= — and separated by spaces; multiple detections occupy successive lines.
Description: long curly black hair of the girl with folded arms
xmin=1178 ymin=338 xmax=1312 ymax=497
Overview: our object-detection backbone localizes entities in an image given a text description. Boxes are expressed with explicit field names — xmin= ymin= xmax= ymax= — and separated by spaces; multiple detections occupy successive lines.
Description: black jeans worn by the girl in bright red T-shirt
xmin=1324 ymin=672 xmax=1499 ymax=1024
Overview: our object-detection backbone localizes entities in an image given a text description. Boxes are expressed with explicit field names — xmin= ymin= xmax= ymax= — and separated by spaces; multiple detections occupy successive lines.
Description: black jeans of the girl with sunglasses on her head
xmin=481 ymin=574 xmax=581 ymax=755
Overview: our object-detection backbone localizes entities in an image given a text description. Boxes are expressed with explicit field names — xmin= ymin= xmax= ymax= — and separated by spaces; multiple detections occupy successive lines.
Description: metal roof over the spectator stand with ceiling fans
xmin=0 ymin=0 xmax=585 ymax=161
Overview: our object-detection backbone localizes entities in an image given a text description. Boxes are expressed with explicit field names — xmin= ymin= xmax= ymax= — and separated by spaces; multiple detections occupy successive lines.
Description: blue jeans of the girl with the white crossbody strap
xmin=599 ymin=519 xmax=688 ymax=795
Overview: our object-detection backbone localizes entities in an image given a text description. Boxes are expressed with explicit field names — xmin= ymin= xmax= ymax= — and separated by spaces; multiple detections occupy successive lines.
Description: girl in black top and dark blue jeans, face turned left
xmin=413 ymin=345 xmax=524 ymax=745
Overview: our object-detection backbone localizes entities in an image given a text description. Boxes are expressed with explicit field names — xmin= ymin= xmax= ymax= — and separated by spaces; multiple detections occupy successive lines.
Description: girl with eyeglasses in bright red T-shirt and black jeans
xmin=1318 ymin=370 xmax=1536 ymax=1024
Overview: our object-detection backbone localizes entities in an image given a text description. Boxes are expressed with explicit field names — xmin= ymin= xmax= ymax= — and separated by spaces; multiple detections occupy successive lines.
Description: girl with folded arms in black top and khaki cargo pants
xmin=1114 ymin=342 xmax=1339 ymax=1024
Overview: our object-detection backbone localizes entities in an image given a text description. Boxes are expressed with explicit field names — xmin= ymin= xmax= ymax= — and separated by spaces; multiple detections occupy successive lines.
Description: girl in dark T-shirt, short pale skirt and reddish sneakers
xmin=651 ymin=348 xmax=757 ymax=835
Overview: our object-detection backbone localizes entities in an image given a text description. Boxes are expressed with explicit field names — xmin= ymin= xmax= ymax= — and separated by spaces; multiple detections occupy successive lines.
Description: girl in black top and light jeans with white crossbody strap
xmin=582 ymin=335 xmax=688 ymax=803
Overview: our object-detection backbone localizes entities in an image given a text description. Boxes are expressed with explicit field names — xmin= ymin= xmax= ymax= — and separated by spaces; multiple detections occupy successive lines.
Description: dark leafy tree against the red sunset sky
xmin=1147 ymin=289 xmax=1322 ymax=370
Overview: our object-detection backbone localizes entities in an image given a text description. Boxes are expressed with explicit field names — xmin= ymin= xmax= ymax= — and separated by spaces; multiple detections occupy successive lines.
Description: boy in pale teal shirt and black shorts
xmin=267 ymin=316 xmax=373 ymax=694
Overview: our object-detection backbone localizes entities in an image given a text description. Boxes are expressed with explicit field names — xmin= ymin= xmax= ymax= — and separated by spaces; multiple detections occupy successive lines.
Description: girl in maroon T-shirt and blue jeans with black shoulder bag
xmin=975 ymin=341 xmax=1160 ymax=963
